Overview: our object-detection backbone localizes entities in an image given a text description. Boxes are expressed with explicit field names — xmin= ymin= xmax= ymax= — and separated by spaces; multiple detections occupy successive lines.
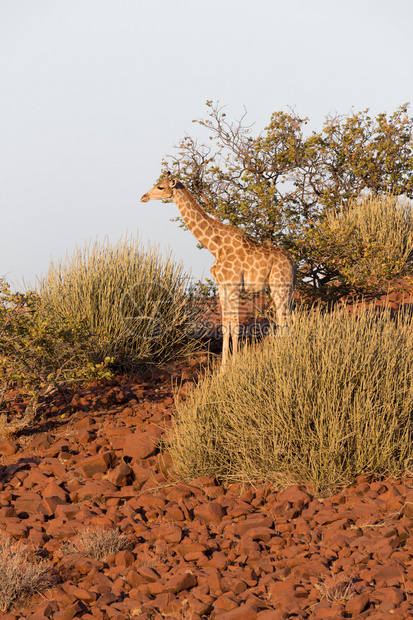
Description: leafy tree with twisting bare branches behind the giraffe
xmin=165 ymin=101 xmax=413 ymax=294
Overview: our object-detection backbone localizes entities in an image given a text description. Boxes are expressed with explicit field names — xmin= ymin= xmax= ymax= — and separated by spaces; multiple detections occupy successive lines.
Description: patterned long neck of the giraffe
xmin=172 ymin=186 xmax=223 ymax=256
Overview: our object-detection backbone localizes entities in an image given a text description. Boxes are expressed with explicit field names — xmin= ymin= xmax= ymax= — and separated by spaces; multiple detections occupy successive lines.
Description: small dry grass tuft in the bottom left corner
xmin=0 ymin=538 xmax=51 ymax=613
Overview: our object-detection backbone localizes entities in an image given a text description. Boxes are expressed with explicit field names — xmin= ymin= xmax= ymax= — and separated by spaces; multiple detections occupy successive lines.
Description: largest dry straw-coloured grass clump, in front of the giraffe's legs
xmin=170 ymin=308 xmax=413 ymax=493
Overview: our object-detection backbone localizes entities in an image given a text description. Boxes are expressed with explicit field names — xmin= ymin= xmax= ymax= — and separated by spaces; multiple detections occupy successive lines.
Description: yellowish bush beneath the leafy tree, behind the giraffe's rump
xmin=295 ymin=195 xmax=413 ymax=301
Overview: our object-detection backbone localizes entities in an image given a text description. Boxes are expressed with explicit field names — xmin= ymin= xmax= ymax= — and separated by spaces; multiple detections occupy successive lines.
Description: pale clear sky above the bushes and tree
xmin=0 ymin=0 xmax=413 ymax=288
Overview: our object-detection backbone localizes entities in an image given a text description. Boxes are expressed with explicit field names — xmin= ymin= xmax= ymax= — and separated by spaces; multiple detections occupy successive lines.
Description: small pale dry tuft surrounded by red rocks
xmin=64 ymin=527 xmax=128 ymax=562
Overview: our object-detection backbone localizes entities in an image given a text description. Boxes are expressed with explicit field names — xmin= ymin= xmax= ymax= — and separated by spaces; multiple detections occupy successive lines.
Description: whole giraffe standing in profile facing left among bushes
xmin=141 ymin=172 xmax=296 ymax=370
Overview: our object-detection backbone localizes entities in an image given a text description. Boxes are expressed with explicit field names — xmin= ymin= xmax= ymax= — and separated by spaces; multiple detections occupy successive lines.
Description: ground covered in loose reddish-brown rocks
xmin=0 ymin=286 xmax=413 ymax=620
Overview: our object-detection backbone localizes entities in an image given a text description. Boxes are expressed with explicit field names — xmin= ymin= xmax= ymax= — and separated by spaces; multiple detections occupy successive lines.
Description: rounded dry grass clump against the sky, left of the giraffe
xmin=39 ymin=239 xmax=199 ymax=371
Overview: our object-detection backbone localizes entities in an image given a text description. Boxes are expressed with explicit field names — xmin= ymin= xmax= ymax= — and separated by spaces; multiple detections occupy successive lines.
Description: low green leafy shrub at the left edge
xmin=0 ymin=280 xmax=111 ymax=397
